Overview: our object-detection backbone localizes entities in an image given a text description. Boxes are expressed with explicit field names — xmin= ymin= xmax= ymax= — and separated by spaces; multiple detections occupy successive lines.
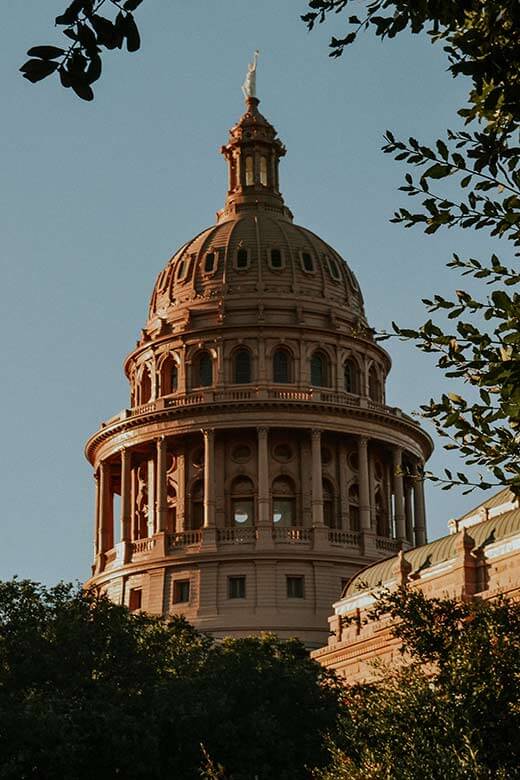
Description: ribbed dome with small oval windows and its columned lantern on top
xmin=146 ymin=98 xmax=366 ymax=335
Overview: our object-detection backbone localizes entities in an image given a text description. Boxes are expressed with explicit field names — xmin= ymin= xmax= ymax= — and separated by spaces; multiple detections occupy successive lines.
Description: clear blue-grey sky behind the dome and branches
xmin=0 ymin=0 xmax=498 ymax=583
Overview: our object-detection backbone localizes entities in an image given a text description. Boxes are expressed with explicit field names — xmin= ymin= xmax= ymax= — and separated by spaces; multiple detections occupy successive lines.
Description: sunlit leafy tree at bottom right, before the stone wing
xmin=315 ymin=588 xmax=520 ymax=780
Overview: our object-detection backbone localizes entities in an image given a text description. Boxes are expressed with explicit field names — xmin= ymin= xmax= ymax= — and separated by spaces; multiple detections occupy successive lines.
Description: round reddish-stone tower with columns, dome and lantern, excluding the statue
xmin=86 ymin=97 xmax=432 ymax=647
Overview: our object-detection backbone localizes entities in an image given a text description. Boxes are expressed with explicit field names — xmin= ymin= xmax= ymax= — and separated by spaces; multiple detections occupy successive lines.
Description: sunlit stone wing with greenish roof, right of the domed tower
xmin=312 ymin=489 xmax=520 ymax=672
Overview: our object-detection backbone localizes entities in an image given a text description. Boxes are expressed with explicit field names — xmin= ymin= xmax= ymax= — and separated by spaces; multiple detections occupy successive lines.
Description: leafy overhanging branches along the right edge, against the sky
xmin=302 ymin=0 xmax=520 ymax=494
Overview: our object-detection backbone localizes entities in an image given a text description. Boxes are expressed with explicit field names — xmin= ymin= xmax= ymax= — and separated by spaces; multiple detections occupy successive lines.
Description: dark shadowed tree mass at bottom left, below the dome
xmin=0 ymin=580 xmax=340 ymax=780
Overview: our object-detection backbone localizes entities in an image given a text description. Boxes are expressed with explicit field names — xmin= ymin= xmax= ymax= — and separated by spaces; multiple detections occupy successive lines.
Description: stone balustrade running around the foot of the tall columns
xmin=99 ymin=526 xmax=409 ymax=571
